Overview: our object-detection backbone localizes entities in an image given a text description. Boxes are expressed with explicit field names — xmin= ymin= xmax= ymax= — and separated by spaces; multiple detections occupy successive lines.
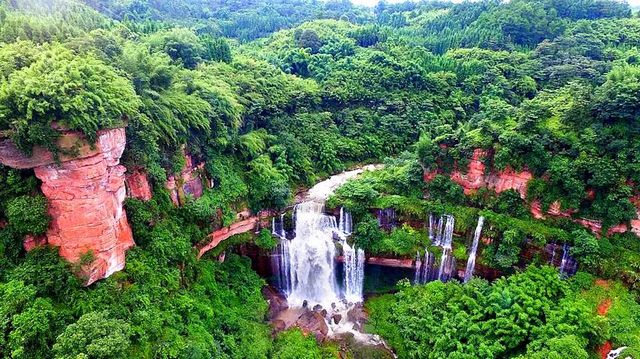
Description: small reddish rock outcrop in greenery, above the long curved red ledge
xmin=166 ymin=149 xmax=208 ymax=206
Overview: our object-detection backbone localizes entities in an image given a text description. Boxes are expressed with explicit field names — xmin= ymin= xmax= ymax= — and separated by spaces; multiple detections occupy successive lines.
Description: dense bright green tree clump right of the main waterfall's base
xmin=367 ymin=267 xmax=600 ymax=358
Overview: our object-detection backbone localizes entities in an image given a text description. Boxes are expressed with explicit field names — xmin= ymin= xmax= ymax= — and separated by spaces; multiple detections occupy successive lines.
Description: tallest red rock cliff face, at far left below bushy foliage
xmin=0 ymin=128 xmax=135 ymax=285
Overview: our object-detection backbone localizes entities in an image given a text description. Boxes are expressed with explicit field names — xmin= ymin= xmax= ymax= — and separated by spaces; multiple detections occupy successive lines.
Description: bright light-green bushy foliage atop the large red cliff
xmin=0 ymin=46 xmax=139 ymax=153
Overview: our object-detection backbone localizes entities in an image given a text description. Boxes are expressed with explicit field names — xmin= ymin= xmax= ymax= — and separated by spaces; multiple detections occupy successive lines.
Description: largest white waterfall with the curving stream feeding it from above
xmin=287 ymin=167 xmax=374 ymax=308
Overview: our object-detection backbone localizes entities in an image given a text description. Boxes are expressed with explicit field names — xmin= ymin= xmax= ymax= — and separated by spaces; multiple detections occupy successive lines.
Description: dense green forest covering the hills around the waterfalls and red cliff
xmin=0 ymin=0 xmax=640 ymax=359
